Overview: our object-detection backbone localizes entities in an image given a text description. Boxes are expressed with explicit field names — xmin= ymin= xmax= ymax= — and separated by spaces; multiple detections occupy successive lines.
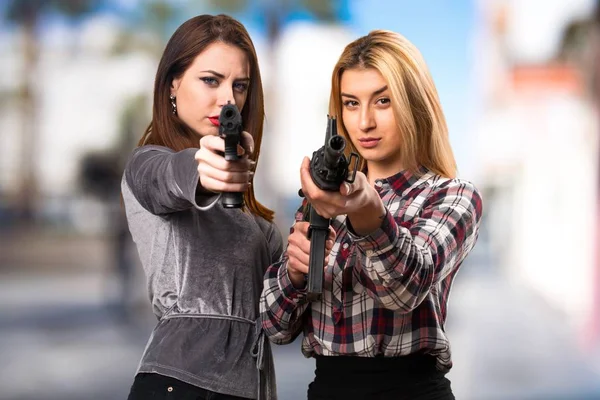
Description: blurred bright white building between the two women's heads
xmin=263 ymin=21 xmax=354 ymax=228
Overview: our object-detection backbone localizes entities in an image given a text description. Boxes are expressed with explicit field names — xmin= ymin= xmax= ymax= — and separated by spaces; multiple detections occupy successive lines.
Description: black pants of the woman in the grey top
xmin=127 ymin=373 xmax=248 ymax=400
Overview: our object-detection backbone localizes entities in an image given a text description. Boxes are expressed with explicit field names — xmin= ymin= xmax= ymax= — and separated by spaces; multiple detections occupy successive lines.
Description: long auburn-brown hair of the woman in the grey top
xmin=138 ymin=14 xmax=274 ymax=221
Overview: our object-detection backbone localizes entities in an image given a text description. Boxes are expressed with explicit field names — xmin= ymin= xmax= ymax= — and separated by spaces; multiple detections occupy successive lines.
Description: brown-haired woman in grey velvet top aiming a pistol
xmin=122 ymin=15 xmax=282 ymax=400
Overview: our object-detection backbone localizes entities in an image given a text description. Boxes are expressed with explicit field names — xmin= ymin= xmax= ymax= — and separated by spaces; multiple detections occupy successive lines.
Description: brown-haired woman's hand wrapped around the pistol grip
xmin=194 ymin=131 xmax=256 ymax=192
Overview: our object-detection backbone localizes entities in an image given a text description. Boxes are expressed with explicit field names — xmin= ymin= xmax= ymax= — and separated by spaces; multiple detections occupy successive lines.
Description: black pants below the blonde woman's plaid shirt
xmin=308 ymin=355 xmax=455 ymax=400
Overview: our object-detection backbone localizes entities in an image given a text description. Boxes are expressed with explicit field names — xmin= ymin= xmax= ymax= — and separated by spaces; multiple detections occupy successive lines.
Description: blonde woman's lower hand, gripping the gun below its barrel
xmin=287 ymin=221 xmax=335 ymax=288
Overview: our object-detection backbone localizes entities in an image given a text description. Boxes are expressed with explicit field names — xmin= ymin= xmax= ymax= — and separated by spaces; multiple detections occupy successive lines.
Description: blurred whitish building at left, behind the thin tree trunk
xmin=0 ymin=15 xmax=156 ymax=230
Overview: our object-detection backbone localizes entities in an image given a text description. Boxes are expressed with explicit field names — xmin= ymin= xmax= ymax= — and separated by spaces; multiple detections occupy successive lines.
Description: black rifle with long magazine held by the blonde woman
xmin=300 ymin=116 xmax=359 ymax=301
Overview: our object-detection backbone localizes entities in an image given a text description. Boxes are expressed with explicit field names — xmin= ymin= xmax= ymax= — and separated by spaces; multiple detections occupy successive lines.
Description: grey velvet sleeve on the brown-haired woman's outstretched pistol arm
xmin=125 ymin=145 xmax=218 ymax=215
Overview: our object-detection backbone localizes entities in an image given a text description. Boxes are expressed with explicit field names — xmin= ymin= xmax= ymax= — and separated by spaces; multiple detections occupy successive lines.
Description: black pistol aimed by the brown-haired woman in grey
xmin=219 ymin=102 xmax=244 ymax=208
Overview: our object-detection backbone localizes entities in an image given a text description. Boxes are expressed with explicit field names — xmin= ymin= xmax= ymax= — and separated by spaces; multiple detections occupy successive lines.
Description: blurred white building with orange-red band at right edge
xmin=475 ymin=0 xmax=600 ymax=344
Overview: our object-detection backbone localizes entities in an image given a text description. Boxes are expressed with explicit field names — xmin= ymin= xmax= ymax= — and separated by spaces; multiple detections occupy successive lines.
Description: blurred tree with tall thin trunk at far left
xmin=5 ymin=0 xmax=100 ymax=224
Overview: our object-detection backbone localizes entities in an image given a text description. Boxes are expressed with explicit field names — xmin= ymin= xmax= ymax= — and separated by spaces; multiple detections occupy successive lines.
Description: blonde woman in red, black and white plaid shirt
xmin=261 ymin=30 xmax=482 ymax=400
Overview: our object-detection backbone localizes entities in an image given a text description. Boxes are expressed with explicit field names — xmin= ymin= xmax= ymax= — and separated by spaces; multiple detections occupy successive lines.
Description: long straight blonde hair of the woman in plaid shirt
xmin=329 ymin=30 xmax=456 ymax=178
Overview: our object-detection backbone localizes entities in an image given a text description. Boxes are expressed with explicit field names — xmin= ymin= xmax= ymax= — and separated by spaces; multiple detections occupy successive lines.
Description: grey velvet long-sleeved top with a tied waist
xmin=121 ymin=146 xmax=282 ymax=399
